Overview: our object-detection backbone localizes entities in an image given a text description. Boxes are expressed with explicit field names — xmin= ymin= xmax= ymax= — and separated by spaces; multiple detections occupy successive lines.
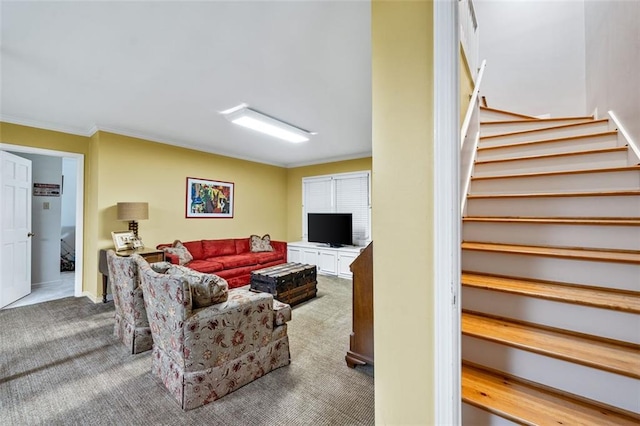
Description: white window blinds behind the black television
xmin=302 ymin=172 xmax=371 ymax=245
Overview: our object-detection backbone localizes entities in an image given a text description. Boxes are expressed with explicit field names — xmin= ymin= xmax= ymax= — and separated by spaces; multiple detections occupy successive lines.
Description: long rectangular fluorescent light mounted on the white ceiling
xmin=220 ymin=104 xmax=316 ymax=143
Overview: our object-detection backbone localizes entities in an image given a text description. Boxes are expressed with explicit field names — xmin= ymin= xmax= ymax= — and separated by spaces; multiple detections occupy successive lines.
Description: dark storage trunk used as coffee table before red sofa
xmin=251 ymin=263 xmax=317 ymax=305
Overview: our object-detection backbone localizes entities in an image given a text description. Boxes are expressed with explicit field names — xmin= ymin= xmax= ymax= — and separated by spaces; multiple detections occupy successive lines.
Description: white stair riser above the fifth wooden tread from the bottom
xmin=467 ymin=196 xmax=640 ymax=218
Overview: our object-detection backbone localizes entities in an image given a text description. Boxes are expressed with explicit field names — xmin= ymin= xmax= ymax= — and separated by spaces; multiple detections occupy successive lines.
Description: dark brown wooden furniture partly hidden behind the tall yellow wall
xmin=345 ymin=242 xmax=373 ymax=368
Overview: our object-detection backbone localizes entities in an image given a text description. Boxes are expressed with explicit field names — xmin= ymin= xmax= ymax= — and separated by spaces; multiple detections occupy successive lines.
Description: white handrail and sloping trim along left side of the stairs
xmin=460 ymin=59 xmax=487 ymax=215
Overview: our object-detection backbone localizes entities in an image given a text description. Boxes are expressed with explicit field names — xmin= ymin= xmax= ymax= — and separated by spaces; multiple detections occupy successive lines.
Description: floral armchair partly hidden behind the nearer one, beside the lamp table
xmin=107 ymin=250 xmax=153 ymax=354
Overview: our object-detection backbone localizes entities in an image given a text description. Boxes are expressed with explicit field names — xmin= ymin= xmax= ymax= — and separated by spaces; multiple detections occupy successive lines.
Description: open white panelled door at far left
xmin=0 ymin=151 xmax=32 ymax=308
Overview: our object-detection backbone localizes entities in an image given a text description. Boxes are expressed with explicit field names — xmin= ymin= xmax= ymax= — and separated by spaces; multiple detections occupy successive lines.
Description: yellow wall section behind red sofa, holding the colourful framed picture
xmin=97 ymin=132 xmax=286 ymax=300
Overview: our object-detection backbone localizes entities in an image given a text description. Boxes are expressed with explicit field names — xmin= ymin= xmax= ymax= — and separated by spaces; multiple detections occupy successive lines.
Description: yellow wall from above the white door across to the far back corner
xmin=0 ymin=123 xmax=287 ymax=300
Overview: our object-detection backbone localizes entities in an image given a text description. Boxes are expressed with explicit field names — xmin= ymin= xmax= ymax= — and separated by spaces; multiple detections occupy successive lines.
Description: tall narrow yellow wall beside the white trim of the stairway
xmin=371 ymin=1 xmax=434 ymax=425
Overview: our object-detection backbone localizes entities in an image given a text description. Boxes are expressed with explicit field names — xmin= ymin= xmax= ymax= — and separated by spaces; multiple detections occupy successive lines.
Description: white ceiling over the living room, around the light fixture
xmin=0 ymin=0 xmax=371 ymax=167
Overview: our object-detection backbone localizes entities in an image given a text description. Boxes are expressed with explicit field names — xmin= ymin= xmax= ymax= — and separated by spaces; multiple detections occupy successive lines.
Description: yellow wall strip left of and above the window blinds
xmin=287 ymin=157 xmax=371 ymax=242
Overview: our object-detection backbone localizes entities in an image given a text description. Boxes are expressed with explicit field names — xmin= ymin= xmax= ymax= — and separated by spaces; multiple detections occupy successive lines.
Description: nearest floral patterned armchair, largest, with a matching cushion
xmin=132 ymin=255 xmax=291 ymax=410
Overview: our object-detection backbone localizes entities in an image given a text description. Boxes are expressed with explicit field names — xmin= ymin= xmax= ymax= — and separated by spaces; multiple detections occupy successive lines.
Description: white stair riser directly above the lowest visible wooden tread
xmin=462 ymin=336 xmax=640 ymax=412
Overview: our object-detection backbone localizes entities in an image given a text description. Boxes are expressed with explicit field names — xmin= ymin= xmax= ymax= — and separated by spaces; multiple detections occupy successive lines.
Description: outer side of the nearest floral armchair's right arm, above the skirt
xmin=184 ymin=289 xmax=274 ymax=371
